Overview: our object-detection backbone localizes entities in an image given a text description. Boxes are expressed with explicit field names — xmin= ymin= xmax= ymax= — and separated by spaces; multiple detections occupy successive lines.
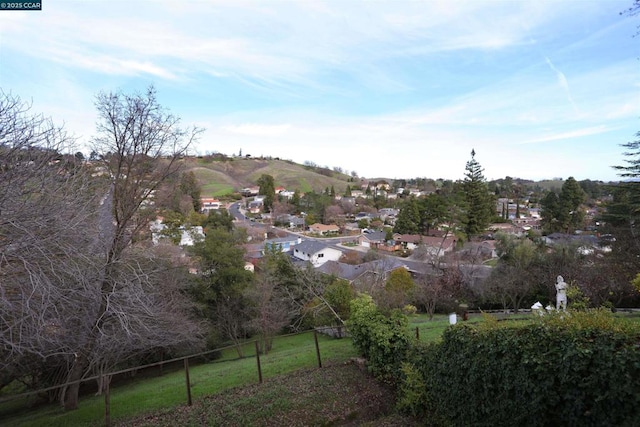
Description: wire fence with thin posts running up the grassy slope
xmin=0 ymin=327 xmax=347 ymax=427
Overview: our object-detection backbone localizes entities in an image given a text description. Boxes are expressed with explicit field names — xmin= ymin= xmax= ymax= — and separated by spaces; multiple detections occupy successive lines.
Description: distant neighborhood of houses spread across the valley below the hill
xmin=152 ymin=168 xmax=608 ymax=294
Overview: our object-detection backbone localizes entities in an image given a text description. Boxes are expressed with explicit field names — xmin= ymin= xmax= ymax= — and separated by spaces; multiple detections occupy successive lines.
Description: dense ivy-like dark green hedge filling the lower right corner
xmin=351 ymin=300 xmax=640 ymax=426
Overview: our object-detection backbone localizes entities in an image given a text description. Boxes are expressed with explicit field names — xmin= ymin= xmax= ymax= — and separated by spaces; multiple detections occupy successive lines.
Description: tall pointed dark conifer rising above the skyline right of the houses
xmin=462 ymin=150 xmax=495 ymax=239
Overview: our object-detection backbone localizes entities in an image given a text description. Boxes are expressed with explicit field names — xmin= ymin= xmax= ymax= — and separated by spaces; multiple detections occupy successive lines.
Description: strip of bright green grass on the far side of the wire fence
xmin=0 ymin=333 xmax=356 ymax=427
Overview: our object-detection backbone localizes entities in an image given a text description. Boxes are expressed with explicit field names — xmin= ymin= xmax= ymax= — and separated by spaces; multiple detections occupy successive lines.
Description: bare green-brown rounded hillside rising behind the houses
xmin=185 ymin=158 xmax=351 ymax=196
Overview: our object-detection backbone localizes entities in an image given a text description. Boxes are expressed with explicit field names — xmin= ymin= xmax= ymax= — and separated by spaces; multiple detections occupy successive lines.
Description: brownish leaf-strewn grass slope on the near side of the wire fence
xmin=125 ymin=363 xmax=420 ymax=427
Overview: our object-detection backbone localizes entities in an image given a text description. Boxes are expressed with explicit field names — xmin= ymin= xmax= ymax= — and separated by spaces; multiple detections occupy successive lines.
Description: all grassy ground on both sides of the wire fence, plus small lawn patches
xmin=0 ymin=315 xmax=548 ymax=427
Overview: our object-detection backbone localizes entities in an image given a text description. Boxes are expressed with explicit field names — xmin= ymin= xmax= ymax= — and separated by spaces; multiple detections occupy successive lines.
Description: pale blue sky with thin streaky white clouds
xmin=0 ymin=0 xmax=640 ymax=181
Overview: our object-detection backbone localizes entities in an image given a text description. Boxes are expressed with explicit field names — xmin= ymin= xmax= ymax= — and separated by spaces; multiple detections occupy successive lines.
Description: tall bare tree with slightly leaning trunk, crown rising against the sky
xmin=61 ymin=88 xmax=200 ymax=409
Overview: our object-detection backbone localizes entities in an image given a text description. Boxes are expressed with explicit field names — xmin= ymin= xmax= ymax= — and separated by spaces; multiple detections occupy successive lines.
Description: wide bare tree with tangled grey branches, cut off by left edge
xmin=0 ymin=93 xmax=105 ymax=396
